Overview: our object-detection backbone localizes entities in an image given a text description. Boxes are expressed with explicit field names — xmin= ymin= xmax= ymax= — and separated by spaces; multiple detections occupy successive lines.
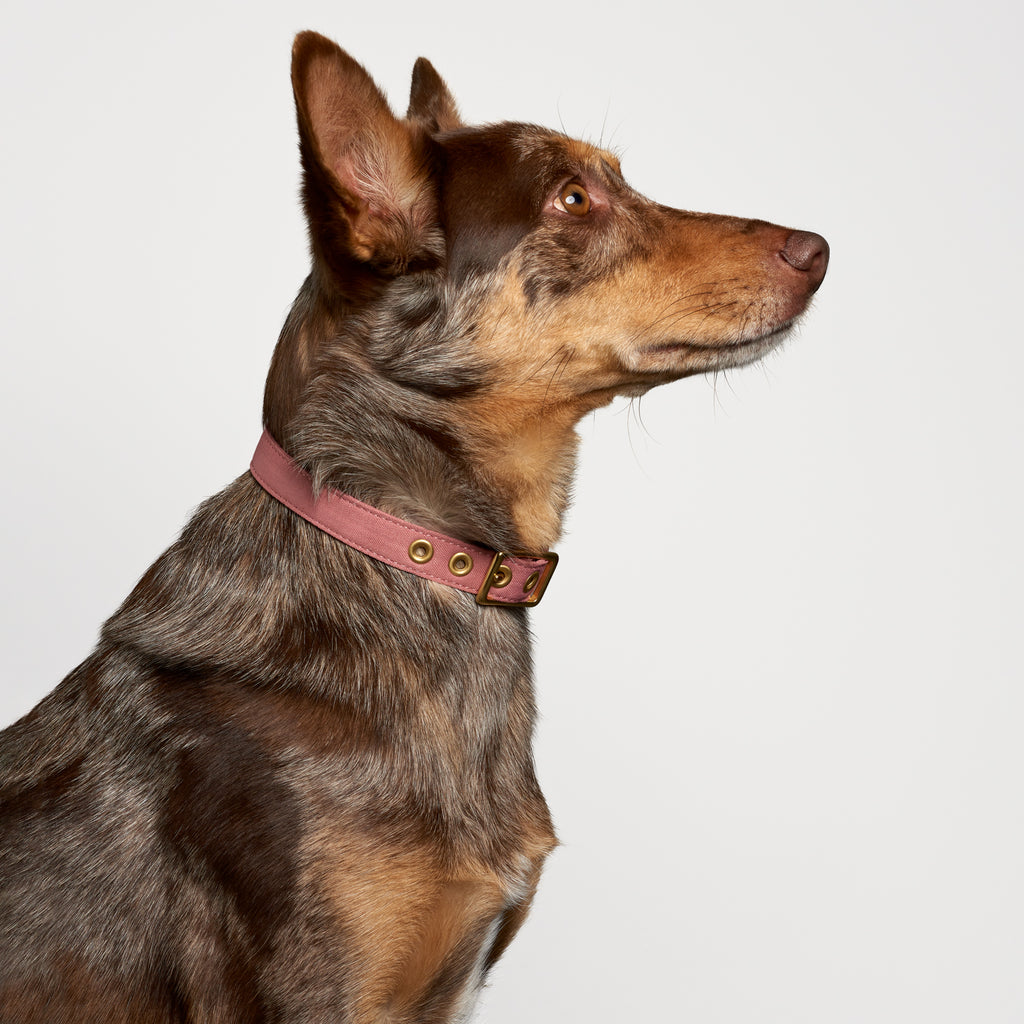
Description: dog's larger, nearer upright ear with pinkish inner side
xmin=292 ymin=32 xmax=440 ymax=275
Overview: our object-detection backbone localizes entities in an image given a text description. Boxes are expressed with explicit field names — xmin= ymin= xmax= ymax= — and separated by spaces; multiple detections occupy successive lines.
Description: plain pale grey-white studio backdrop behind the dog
xmin=0 ymin=0 xmax=1024 ymax=1024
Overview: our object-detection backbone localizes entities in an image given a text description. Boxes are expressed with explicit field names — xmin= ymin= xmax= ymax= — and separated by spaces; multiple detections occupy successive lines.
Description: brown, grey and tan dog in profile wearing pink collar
xmin=0 ymin=32 xmax=828 ymax=1024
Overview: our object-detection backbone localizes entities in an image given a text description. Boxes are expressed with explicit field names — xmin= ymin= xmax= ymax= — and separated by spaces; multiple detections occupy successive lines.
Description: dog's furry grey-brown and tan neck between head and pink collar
xmin=264 ymin=278 xmax=582 ymax=551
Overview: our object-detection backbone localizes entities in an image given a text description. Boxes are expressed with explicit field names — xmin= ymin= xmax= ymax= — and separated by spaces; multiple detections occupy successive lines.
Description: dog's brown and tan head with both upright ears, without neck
xmin=293 ymin=33 xmax=828 ymax=391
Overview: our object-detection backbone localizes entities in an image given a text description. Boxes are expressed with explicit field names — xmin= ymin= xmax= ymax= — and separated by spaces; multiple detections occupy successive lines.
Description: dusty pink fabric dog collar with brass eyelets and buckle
xmin=249 ymin=430 xmax=558 ymax=607
